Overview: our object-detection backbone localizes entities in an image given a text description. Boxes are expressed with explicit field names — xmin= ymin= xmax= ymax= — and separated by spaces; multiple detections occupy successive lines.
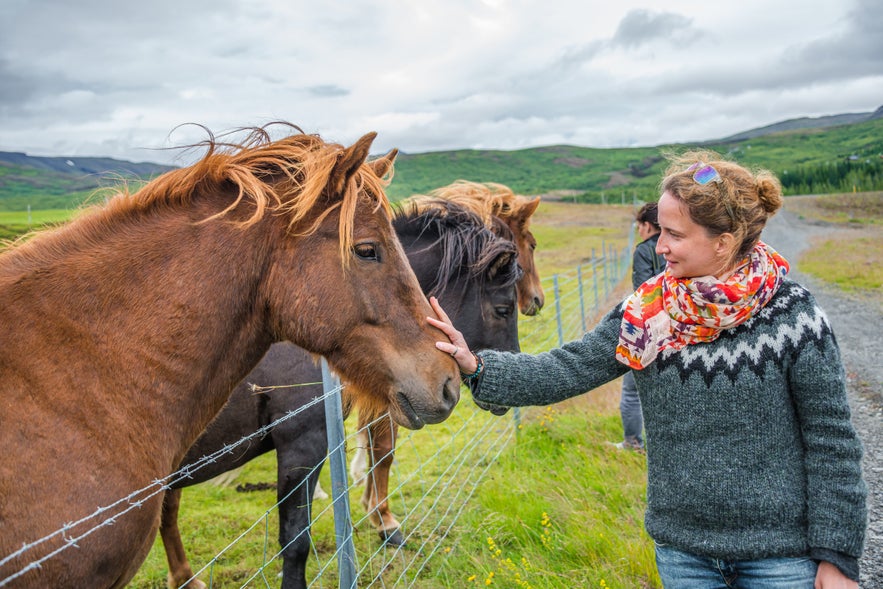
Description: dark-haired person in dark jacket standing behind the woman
xmin=614 ymin=202 xmax=665 ymax=451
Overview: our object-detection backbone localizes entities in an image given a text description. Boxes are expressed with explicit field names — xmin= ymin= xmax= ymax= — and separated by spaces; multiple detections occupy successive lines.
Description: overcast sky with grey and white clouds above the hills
xmin=0 ymin=0 xmax=883 ymax=165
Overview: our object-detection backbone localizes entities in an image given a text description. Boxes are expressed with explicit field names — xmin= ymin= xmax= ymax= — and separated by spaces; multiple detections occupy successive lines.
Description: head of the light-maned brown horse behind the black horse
xmin=418 ymin=180 xmax=546 ymax=315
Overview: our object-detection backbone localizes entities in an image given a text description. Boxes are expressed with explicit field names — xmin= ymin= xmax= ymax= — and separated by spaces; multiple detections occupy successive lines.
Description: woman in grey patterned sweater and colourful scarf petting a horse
xmin=429 ymin=152 xmax=867 ymax=589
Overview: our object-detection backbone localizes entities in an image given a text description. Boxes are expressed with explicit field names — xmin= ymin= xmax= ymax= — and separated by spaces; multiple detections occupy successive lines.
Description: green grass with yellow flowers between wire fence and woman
xmin=424 ymin=403 xmax=659 ymax=589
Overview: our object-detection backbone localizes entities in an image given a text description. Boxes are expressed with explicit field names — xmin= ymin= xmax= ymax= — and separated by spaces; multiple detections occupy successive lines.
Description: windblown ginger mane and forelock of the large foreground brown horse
xmin=1 ymin=122 xmax=392 ymax=268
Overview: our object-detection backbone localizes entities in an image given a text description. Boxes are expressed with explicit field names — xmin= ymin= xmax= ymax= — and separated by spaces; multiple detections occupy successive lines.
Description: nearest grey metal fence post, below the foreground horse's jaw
xmin=322 ymin=358 xmax=358 ymax=589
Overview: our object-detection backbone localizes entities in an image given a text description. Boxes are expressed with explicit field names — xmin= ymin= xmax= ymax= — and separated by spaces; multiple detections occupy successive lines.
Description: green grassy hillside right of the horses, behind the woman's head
xmin=389 ymin=119 xmax=883 ymax=202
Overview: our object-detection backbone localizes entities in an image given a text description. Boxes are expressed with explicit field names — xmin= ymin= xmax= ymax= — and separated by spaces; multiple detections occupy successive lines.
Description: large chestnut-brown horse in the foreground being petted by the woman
xmin=0 ymin=121 xmax=459 ymax=587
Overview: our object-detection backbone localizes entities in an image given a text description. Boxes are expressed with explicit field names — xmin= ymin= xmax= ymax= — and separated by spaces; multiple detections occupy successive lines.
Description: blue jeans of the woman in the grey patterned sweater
xmin=656 ymin=544 xmax=818 ymax=589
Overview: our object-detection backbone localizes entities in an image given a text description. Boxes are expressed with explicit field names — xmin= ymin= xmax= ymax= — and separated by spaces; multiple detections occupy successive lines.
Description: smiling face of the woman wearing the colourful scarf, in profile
xmin=656 ymin=191 xmax=733 ymax=279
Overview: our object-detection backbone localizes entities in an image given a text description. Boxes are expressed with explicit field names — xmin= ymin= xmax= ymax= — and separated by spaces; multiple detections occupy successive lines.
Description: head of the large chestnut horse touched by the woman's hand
xmin=250 ymin=133 xmax=459 ymax=429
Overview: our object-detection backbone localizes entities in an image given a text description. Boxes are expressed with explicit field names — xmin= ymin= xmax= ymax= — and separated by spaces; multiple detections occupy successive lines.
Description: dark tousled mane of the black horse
xmin=393 ymin=196 xmax=520 ymax=296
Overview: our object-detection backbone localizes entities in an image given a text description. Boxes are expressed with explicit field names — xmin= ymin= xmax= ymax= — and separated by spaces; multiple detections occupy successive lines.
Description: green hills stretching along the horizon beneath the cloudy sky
xmin=0 ymin=118 xmax=883 ymax=211
